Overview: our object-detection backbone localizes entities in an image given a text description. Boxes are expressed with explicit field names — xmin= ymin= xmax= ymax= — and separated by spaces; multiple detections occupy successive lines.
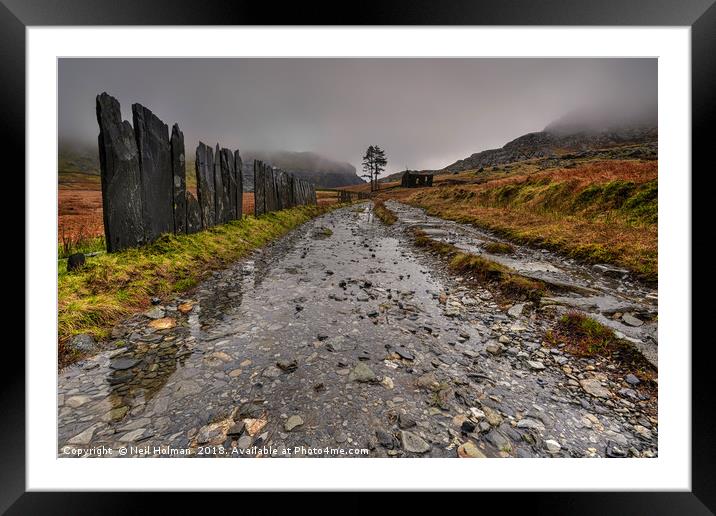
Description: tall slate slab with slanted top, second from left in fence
xmin=132 ymin=104 xmax=174 ymax=242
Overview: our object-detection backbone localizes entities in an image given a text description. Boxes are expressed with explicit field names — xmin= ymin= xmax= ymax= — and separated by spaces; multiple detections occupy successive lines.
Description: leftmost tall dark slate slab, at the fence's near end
xmin=96 ymin=93 xmax=145 ymax=253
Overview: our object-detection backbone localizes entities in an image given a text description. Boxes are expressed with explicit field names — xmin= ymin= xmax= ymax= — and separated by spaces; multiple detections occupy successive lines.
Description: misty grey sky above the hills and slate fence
xmin=59 ymin=58 xmax=657 ymax=173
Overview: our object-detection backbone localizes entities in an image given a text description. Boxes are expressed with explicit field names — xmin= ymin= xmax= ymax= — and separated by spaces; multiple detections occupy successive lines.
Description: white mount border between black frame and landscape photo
xmin=26 ymin=27 xmax=691 ymax=491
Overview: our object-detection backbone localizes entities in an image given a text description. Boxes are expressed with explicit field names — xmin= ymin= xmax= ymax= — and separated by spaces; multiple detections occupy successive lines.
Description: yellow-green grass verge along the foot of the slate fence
xmin=57 ymin=205 xmax=332 ymax=365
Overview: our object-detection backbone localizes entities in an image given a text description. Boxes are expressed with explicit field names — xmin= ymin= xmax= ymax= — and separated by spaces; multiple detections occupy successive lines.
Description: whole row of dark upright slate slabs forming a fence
xmin=96 ymin=93 xmax=316 ymax=252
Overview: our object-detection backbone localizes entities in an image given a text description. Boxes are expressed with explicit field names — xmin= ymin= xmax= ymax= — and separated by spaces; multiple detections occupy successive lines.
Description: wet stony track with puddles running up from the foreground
xmin=58 ymin=203 xmax=657 ymax=457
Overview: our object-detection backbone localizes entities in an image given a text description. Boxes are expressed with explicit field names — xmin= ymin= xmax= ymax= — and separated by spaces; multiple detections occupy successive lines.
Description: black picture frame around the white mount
xmin=0 ymin=0 xmax=716 ymax=515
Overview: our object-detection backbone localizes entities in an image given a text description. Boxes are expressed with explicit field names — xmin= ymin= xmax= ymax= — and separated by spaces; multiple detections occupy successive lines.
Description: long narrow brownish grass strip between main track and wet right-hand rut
xmin=413 ymin=229 xmax=546 ymax=301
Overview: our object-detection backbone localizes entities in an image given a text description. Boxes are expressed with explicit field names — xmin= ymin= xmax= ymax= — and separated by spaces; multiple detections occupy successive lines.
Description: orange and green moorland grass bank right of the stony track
xmin=384 ymin=160 xmax=658 ymax=281
